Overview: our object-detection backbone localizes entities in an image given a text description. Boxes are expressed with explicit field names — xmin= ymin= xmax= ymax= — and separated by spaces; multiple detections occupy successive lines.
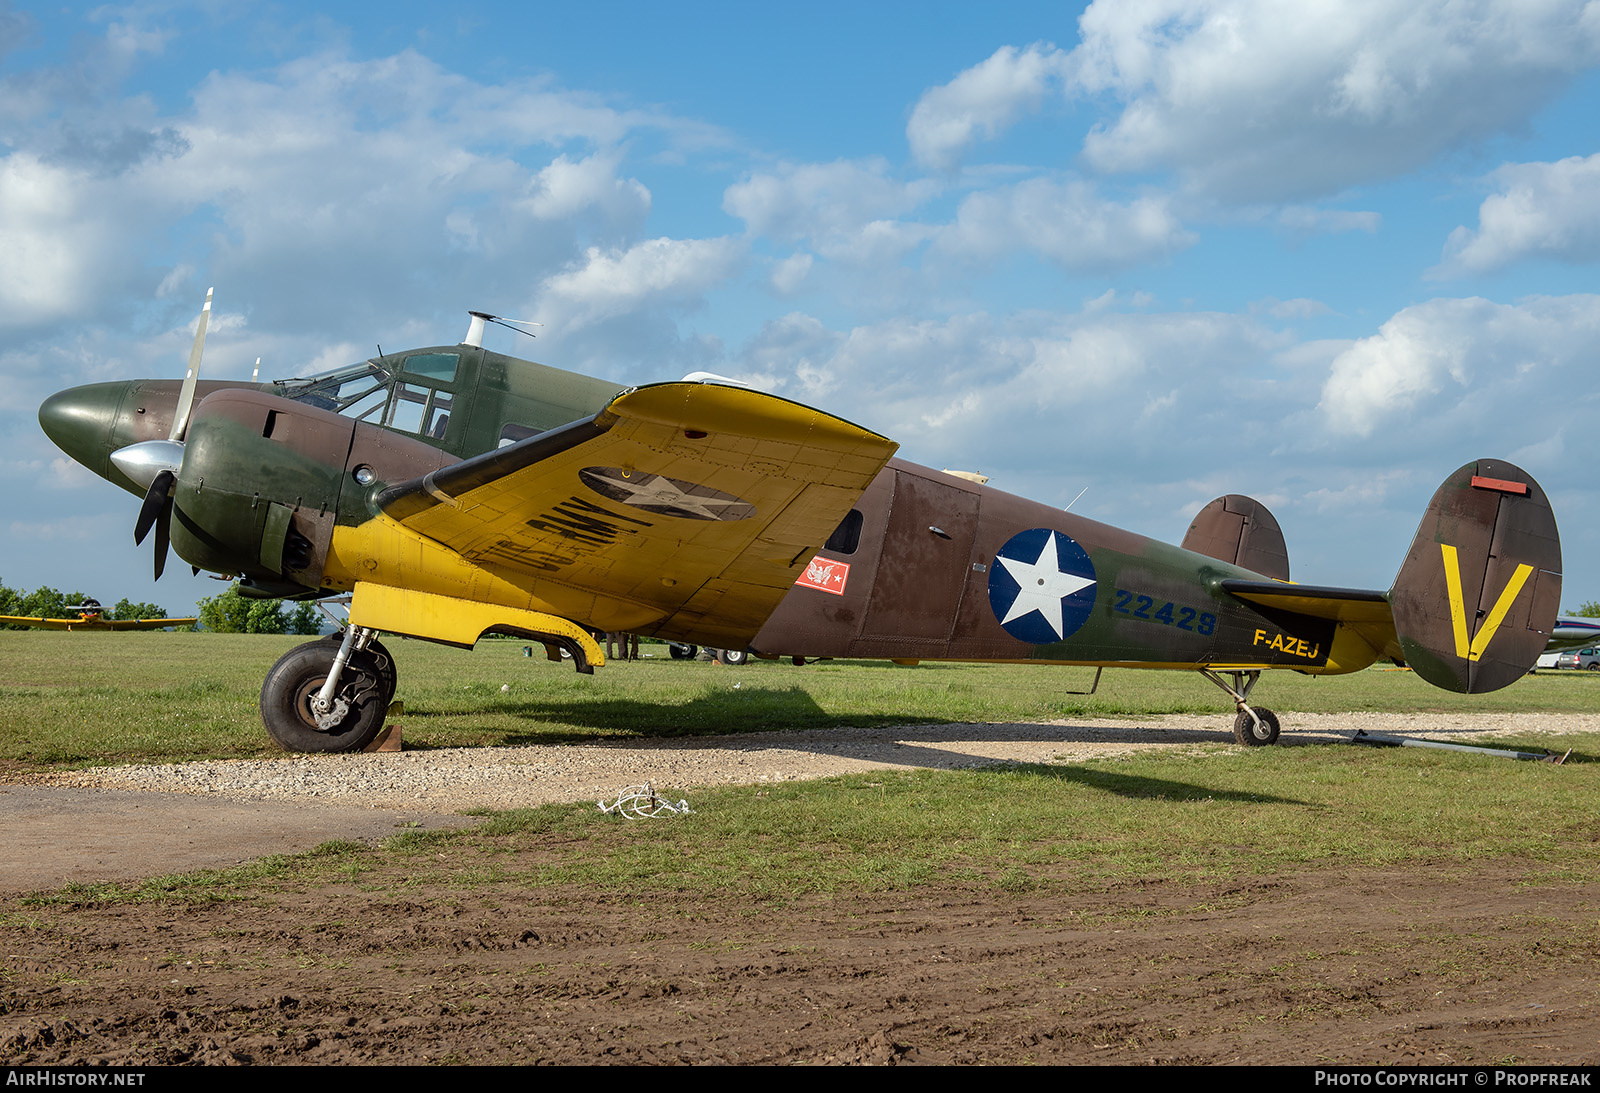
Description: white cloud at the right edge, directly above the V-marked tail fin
xmin=1430 ymin=154 xmax=1600 ymax=277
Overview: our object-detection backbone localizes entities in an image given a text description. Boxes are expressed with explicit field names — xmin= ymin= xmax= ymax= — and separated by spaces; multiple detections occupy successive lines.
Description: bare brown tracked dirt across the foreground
xmin=0 ymin=716 xmax=1600 ymax=1064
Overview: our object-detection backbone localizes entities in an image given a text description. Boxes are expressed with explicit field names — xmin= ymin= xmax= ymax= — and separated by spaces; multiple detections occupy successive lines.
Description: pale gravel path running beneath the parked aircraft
xmin=40 ymin=714 xmax=1600 ymax=813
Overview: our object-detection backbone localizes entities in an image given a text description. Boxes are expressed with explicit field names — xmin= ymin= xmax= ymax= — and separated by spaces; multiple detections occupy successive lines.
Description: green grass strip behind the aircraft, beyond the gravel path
xmin=0 ymin=632 xmax=1600 ymax=768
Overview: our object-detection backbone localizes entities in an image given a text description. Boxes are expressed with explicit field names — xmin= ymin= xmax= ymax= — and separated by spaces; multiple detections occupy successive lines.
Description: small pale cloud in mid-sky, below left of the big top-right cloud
xmin=934 ymin=179 xmax=1195 ymax=272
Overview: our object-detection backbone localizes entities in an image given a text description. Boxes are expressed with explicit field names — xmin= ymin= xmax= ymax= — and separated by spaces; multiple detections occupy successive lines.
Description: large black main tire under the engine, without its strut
xmin=261 ymin=640 xmax=394 ymax=752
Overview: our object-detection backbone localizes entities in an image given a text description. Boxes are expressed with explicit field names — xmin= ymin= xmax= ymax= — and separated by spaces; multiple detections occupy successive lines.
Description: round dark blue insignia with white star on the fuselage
xmin=989 ymin=528 xmax=1096 ymax=645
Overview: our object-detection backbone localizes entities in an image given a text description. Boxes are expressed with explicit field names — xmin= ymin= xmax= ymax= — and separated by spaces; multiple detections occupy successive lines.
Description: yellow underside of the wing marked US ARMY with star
xmin=378 ymin=382 xmax=898 ymax=647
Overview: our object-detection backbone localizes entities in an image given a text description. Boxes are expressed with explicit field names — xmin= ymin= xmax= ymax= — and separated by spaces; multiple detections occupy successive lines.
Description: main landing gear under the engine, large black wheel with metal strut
xmin=261 ymin=626 xmax=395 ymax=752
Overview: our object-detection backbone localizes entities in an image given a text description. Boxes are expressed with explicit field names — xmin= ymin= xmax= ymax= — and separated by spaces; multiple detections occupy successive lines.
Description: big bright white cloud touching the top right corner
xmin=1069 ymin=0 xmax=1600 ymax=200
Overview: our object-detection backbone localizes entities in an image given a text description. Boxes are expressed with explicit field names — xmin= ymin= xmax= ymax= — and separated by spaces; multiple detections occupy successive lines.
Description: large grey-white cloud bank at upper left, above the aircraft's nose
xmin=0 ymin=42 xmax=706 ymax=336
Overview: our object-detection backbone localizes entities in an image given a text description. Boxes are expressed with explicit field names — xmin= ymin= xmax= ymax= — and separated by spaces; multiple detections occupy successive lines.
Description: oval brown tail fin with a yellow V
xmin=1389 ymin=459 xmax=1562 ymax=695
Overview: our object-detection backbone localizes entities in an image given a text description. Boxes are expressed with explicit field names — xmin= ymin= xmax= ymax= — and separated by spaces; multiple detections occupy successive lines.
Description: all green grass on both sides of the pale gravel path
xmin=0 ymin=634 xmax=1600 ymax=896
